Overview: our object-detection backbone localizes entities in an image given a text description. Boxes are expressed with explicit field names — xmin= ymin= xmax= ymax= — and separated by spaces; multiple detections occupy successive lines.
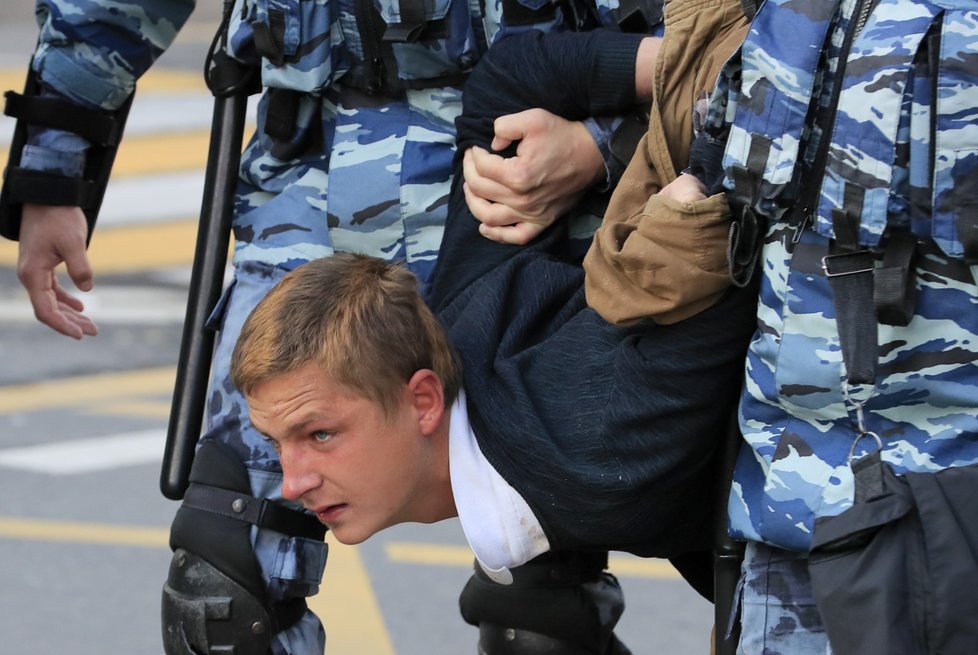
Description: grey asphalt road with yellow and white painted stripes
xmin=0 ymin=0 xmax=712 ymax=655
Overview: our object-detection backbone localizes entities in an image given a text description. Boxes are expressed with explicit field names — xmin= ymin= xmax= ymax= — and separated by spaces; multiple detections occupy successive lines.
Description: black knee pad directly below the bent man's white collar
xmin=459 ymin=553 xmax=628 ymax=655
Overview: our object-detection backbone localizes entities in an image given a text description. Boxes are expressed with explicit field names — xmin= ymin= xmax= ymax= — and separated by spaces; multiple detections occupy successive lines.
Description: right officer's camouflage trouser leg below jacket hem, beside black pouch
xmin=737 ymin=541 xmax=832 ymax=655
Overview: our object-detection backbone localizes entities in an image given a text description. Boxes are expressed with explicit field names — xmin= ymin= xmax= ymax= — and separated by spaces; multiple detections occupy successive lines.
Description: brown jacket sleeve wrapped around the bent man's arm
xmin=584 ymin=0 xmax=748 ymax=323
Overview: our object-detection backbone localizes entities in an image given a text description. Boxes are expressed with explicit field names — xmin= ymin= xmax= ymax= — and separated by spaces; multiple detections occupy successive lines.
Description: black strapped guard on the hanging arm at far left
xmin=0 ymin=70 xmax=133 ymax=240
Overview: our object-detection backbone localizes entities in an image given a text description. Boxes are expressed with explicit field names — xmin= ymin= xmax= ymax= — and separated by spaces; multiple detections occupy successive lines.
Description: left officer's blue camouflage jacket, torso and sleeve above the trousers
xmin=33 ymin=0 xmax=662 ymax=110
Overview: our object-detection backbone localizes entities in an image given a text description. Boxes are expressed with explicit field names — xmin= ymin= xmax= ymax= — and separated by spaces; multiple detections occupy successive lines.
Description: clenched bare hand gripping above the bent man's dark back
xmin=463 ymin=109 xmax=605 ymax=244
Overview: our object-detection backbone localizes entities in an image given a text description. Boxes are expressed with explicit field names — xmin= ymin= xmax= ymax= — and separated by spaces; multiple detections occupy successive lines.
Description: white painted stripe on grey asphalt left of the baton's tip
xmin=0 ymin=430 xmax=166 ymax=475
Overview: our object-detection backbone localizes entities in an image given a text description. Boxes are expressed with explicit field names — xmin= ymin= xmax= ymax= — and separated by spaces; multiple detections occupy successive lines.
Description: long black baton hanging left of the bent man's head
xmin=160 ymin=1 xmax=257 ymax=500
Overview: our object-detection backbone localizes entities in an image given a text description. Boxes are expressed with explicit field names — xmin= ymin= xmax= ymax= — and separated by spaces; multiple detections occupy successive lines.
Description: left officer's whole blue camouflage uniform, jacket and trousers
xmin=15 ymin=0 xmax=660 ymax=653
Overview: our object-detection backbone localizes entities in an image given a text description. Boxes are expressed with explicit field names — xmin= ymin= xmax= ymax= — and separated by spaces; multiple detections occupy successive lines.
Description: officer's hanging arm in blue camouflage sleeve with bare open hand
xmin=4 ymin=0 xmax=194 ymax=339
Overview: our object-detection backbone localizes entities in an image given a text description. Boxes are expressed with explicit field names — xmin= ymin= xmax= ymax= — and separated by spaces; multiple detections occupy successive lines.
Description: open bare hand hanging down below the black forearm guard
xmin=17 ymin=204 xmax=98 ymax=339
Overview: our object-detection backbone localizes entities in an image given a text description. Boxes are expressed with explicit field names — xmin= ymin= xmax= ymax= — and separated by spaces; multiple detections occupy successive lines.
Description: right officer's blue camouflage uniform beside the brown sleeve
xmin=711 ymin=0 xmax=978 ymax=655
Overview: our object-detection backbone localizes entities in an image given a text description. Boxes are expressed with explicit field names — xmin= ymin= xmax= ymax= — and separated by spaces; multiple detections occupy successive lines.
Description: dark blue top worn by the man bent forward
xmin=428 ymin=30 xmax=756 ymax=557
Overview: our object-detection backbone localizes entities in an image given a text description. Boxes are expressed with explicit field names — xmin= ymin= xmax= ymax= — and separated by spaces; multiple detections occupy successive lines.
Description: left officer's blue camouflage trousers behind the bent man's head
xmin=202 ymin=84 xmax=460 ymax=655
